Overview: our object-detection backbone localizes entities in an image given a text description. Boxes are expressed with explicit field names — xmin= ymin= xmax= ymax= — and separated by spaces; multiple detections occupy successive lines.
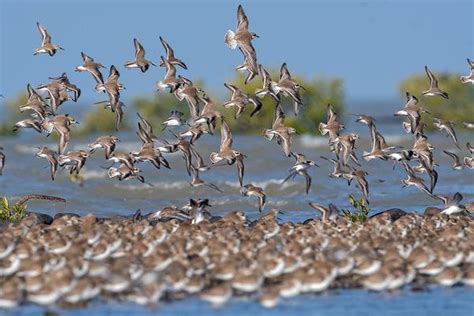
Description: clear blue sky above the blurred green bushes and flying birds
xmin=0 ymin=0 xmax=474 ymax=101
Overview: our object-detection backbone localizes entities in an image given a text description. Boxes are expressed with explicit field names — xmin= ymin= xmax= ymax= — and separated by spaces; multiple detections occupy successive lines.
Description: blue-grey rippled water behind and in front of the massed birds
xmin=0 ymin=108 xmax=474 ymax=315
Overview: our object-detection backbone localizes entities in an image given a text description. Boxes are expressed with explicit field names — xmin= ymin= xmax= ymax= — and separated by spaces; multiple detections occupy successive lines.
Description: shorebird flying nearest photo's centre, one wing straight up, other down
xmin=209 ymin=119 xmax=245 ymax=186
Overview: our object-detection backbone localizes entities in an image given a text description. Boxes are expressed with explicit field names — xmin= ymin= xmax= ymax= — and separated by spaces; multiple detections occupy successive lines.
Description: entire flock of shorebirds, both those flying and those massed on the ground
xmin=0 ymin=6 xmax=474 ymax=308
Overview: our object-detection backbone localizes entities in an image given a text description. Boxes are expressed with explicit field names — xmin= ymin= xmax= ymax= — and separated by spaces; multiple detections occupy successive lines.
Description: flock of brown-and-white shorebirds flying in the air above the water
xmin=0 ymin=6 xmax=474 ymax=214
